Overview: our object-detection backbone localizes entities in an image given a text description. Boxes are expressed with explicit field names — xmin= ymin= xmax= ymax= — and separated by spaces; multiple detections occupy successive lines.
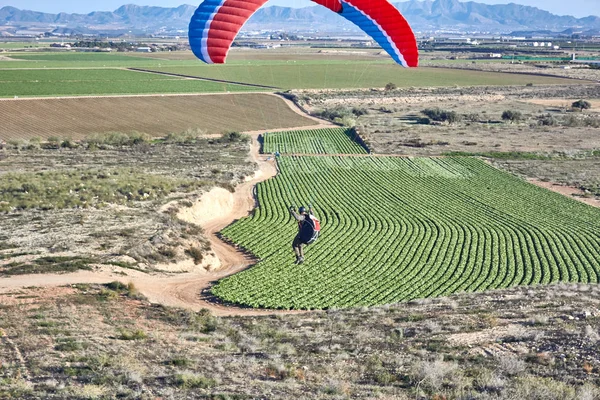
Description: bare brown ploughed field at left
xmin=0 ymin=93 xmax=315 ymax=141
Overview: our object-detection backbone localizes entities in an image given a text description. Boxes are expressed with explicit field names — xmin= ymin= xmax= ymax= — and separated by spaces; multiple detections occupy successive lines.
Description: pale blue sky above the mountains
xmin=0 ymin=0 xmax=600 ymax=17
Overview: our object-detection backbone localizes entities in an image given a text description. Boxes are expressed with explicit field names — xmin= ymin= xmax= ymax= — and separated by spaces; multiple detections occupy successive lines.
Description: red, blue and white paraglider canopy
xmin=189 ymin=0 xmax=419 ymax=67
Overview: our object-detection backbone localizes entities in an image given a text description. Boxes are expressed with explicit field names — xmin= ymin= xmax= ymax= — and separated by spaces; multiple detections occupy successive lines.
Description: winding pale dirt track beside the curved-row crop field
xmin=0 ymin=99 xmax=334 ymax=316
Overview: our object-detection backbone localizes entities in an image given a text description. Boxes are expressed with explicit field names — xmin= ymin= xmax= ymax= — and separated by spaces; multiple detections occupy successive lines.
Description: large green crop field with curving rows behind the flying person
xmin=212 ymin=156 xmax=600 ymax=309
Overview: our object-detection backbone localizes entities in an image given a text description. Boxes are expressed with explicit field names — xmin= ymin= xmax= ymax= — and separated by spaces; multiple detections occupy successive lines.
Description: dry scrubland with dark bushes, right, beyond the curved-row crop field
xmin=291 ymin=85 xmax=600 ymax=195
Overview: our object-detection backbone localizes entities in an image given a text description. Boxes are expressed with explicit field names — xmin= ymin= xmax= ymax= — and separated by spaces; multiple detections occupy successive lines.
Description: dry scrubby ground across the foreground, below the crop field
xmin=0 ymin=283 xmax=600 ymax=400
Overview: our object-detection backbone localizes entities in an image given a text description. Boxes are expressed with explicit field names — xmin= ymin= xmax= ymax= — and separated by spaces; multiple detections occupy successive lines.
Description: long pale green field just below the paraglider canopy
xmin=144 ymin=64 xmax=576 ymax=89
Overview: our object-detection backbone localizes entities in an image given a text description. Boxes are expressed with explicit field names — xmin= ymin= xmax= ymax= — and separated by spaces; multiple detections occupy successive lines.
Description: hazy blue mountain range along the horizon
xmin=0 ymin=0 xmax=600 ymax=35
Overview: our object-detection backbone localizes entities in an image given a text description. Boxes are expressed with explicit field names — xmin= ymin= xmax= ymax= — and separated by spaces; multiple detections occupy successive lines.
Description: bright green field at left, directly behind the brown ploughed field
xmin=0 ymin=69 xmax=259 ymax=97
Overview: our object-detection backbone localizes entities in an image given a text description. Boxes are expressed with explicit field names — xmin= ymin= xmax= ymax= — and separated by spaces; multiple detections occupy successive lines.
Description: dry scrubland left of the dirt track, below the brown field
xmin=0 ymin=134 xmax=255 ymax=275
